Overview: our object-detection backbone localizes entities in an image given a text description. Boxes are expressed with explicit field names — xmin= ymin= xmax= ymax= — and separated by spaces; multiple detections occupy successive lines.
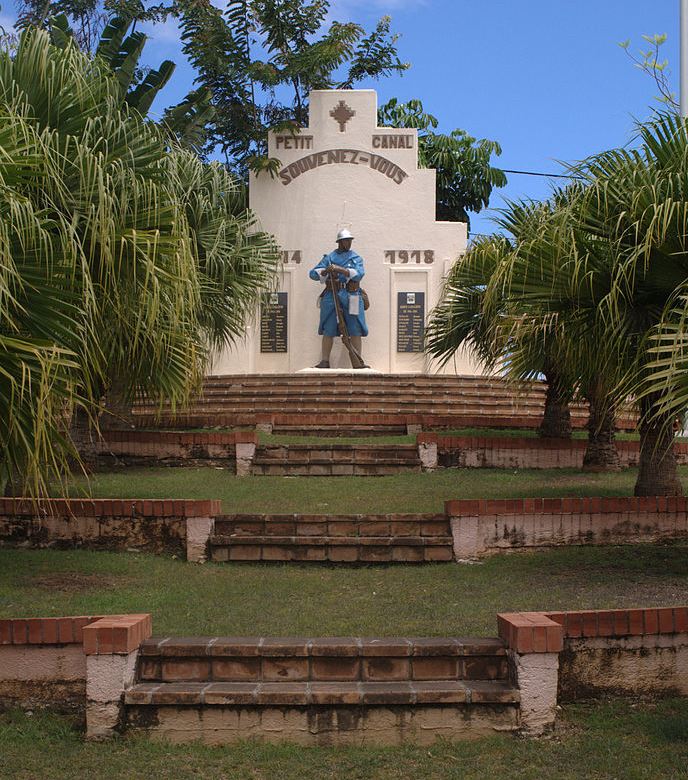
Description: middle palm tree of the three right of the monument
xmin=493 ymin=195 xmax=625 ymax=471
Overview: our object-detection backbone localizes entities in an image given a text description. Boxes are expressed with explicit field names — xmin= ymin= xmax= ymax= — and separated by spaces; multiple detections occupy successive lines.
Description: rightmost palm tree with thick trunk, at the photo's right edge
xmin=576 ymin=114 xmax=688 ymax=495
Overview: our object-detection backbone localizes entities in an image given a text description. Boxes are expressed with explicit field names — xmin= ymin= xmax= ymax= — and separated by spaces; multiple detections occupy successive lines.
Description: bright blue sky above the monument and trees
xmin=0 ymin=0 xmax=679 ymax=233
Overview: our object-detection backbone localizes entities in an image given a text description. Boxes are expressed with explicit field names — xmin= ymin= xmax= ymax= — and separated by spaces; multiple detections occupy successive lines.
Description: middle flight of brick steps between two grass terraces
xmin=210 ymin=514 xmax=454 ymax=564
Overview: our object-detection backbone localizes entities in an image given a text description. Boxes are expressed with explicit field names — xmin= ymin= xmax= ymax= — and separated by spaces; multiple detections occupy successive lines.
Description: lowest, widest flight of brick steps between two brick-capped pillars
xmin=124 ymin=637 xmax=520 ymax=744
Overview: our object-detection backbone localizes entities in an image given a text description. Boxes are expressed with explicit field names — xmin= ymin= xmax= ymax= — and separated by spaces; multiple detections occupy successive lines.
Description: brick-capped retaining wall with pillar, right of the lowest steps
xmin=497 ymin=606 xmax=688 ymax=734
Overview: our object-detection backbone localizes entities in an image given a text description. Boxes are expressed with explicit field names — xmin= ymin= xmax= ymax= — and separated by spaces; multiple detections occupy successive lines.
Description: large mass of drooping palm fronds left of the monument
xmin=0 ymin=30 xmax=278 ymax=489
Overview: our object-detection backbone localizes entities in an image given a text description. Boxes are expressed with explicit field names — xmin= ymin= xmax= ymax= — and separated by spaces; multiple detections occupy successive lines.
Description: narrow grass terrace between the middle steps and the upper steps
xmin=66 ymin=466 xmax=688 ymax=514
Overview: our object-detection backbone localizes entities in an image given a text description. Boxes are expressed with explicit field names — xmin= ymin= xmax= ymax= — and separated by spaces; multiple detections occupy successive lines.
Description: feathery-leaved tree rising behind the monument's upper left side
xmin=177 ymin=0 xmax=408 ymax=176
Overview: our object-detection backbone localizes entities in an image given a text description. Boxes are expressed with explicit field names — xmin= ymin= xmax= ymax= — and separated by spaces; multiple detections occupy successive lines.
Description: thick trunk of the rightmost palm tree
xmin=634 ymin=395 xmax=683 ymax=496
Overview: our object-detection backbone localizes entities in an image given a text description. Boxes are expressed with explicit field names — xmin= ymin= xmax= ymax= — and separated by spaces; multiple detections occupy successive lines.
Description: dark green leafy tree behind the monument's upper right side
xmin=378 ymin=98 xmax=507 ymax=224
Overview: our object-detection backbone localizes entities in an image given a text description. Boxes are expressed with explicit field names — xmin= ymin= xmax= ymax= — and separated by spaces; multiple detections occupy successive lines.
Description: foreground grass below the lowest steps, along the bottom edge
xmin=0 ymin=699 xmax=688 ymax=780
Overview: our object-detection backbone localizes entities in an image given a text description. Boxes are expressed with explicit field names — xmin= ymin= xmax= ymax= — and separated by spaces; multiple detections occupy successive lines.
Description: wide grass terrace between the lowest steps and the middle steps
xmin=0 ymin=543 xmax=688 ymax=640
